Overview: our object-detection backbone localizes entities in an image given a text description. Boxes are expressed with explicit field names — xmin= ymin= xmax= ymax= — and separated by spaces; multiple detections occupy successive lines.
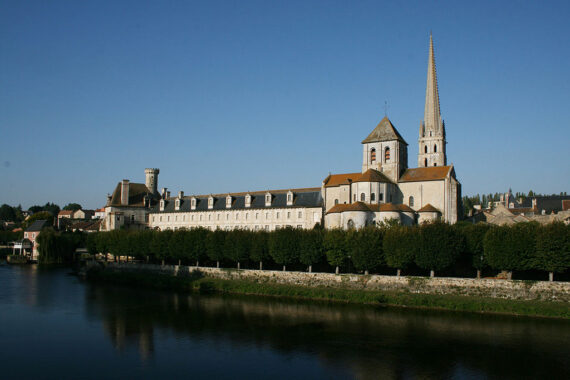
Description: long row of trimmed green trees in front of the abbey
xmin=86 ymin=222 xmax=570 ymax=280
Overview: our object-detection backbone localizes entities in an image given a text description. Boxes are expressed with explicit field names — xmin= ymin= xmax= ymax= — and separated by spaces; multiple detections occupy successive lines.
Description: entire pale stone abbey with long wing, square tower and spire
xmin=101 ymin=36 xmax=461 ymax=231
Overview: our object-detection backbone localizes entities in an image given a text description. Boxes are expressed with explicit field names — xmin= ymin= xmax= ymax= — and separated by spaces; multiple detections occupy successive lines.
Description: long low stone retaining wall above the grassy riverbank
xmin=103 ymin=262 xmax=570 ymax=302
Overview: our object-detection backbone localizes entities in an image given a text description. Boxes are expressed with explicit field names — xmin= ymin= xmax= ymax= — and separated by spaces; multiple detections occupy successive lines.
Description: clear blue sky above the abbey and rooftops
xmin=0 ymin=0 xmax=570 ymax=208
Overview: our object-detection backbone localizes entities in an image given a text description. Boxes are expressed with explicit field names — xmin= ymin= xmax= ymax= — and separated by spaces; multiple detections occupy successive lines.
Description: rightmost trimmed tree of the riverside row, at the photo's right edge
xmin=536 ymin=222 xmax=570 ymax=281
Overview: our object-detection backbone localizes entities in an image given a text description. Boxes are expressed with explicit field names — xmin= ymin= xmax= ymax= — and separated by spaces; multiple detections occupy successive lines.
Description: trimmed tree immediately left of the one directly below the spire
xmin=383 ymin=226 xmax=420 ymax=269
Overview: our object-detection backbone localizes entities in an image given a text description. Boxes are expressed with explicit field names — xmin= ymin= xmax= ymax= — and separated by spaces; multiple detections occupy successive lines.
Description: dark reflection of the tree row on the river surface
xmin=87 ymin=285 xmax=570 ymax=379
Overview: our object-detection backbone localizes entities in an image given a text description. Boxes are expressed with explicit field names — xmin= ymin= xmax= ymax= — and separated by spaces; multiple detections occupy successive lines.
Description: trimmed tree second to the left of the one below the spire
xmin=347 ymin=227 xmax=384 ymax=275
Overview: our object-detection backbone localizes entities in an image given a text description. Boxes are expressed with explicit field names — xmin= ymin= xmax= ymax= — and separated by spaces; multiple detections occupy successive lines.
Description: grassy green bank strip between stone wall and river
xmin=88 ymin=271 xmax=570 ymax=319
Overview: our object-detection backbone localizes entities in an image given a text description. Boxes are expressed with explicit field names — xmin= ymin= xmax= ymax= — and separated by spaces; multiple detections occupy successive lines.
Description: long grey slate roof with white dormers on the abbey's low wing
xmin=150 ymin=190 xmax=323 ymax=213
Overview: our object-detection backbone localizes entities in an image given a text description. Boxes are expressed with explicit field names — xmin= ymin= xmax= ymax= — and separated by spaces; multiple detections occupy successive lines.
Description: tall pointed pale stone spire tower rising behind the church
xmin=418 ymin=33 xmax=447 ymax=168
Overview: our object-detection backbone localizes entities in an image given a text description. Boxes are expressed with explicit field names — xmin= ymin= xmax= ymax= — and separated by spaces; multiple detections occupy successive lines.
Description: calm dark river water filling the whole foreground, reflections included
xmin=0 ymin=265 xmax=570 ymax=379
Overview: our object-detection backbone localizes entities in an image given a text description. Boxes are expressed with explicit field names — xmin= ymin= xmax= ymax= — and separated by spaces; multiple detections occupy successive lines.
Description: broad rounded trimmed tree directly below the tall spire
xmin=415 ymin=222 xmax=465 ymax=271
